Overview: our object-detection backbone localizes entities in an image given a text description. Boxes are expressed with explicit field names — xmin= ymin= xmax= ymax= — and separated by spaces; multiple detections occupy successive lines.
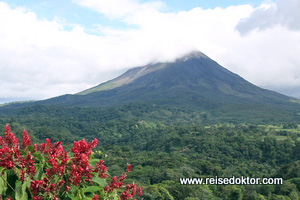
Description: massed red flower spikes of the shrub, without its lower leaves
xmin=0 ymin=125 xmax=142 ymax=200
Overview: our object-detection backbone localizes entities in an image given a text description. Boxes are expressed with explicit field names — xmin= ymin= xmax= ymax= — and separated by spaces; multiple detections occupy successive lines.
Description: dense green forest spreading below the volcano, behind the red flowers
xmin=0 ymin=104 xmax=300 ymax=200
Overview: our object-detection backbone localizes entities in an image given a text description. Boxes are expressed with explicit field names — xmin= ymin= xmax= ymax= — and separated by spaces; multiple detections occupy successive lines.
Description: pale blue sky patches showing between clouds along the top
xmin=3 ymin=0 xmax=268 ymax=35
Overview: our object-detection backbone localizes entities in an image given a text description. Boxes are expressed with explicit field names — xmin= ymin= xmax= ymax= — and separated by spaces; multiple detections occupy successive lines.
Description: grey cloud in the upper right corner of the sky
xmin=236 ymin=0 xmax=300 ymax=34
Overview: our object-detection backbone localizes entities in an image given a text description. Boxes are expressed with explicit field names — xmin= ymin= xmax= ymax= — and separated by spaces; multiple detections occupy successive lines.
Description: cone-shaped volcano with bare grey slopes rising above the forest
xmin=0 ymin=51 xmax=300 ymax=122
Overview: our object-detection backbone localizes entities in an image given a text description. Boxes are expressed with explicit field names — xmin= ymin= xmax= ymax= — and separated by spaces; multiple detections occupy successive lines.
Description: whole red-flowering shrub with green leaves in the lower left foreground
xmin=0 ymin=125 xmax=142 ymax=200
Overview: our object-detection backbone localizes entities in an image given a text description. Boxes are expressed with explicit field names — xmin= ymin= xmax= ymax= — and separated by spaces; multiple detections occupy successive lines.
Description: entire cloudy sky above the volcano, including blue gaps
xmin=0 ymin=0 xmax=300 ymax=103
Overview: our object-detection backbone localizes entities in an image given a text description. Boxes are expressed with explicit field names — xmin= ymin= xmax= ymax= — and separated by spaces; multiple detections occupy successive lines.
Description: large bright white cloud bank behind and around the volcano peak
xmin=0 ymin=0 xmax=300 ymax=103
